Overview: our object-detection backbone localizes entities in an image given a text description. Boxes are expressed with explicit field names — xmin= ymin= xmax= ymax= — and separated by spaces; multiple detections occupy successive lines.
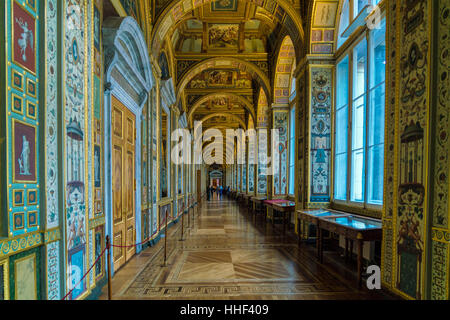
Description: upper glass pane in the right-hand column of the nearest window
xmin=370 ymin=19 xmax=386 ymax=88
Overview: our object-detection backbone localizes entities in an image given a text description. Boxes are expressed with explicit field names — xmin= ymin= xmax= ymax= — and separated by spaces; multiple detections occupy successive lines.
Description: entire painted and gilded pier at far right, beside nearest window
xmin=382 ymin=0 xmax=450 ymax=300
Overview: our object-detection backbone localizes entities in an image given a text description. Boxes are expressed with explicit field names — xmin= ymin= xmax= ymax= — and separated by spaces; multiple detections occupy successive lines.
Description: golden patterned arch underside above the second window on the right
xmin=273 ymin=36 xmax=295 ymax=104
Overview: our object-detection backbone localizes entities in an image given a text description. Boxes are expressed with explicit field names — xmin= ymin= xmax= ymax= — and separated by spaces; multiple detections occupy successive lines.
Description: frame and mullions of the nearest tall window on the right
xmin=331 ymin=7 xmax=388 ymax=212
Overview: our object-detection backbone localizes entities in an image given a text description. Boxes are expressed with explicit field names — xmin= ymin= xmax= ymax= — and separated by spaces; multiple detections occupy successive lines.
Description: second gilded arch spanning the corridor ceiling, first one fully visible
xmin=176 ymin=57 xmax=271 ymax=105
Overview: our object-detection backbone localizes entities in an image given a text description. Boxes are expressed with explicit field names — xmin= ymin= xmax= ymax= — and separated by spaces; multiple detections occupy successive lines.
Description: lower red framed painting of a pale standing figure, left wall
xmin=12 ymin=119 xmax=37 ymax=183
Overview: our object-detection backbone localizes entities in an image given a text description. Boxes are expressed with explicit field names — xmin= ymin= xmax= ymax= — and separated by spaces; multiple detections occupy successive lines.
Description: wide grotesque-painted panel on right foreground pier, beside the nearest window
xmin=393 ymin=1 xmax=432 ymax=299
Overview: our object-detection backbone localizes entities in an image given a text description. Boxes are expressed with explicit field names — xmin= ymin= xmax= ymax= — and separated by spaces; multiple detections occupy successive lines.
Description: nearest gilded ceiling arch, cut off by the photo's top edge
xmin=151 ymin=0 xmax=304 ymax=58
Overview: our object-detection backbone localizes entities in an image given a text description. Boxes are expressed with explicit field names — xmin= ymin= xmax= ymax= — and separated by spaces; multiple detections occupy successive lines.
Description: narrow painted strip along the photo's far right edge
xmin=430 ymin=0 xmax=450 ymax=300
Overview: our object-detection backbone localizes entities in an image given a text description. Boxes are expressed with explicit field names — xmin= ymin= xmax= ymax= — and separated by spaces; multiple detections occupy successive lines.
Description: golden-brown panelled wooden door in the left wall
xmin=111 ymin=96 xmax=136 ymax=270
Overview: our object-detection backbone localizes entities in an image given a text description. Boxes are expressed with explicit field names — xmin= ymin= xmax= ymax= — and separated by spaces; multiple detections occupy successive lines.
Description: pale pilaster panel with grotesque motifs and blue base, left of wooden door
xmin=63 ymin=0 xmax=89 ymax=299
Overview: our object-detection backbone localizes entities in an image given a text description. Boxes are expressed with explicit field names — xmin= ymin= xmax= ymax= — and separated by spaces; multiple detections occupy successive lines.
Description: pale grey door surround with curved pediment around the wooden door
xmin=103 ymin=17 xmax=155 ymax=272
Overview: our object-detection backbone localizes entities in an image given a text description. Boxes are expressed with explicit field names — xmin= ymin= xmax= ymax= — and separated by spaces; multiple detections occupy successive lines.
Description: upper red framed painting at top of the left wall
xmin=11 ymin=1 xmax=37 ymax=75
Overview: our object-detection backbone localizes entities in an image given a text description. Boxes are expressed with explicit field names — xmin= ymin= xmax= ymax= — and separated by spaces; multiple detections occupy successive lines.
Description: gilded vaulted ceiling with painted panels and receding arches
xmin=152 ymin=0 xmax=304 ymax=165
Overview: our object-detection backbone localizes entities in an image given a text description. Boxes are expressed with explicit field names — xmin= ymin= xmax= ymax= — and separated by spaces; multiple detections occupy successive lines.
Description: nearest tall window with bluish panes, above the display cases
xmin=334 ymin=0 xmax=386 ymax=207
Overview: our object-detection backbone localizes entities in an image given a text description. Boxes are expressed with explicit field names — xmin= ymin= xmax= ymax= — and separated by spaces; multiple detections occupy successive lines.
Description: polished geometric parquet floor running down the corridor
xmin=100 ymin=199 xmax=393 ymax=300
